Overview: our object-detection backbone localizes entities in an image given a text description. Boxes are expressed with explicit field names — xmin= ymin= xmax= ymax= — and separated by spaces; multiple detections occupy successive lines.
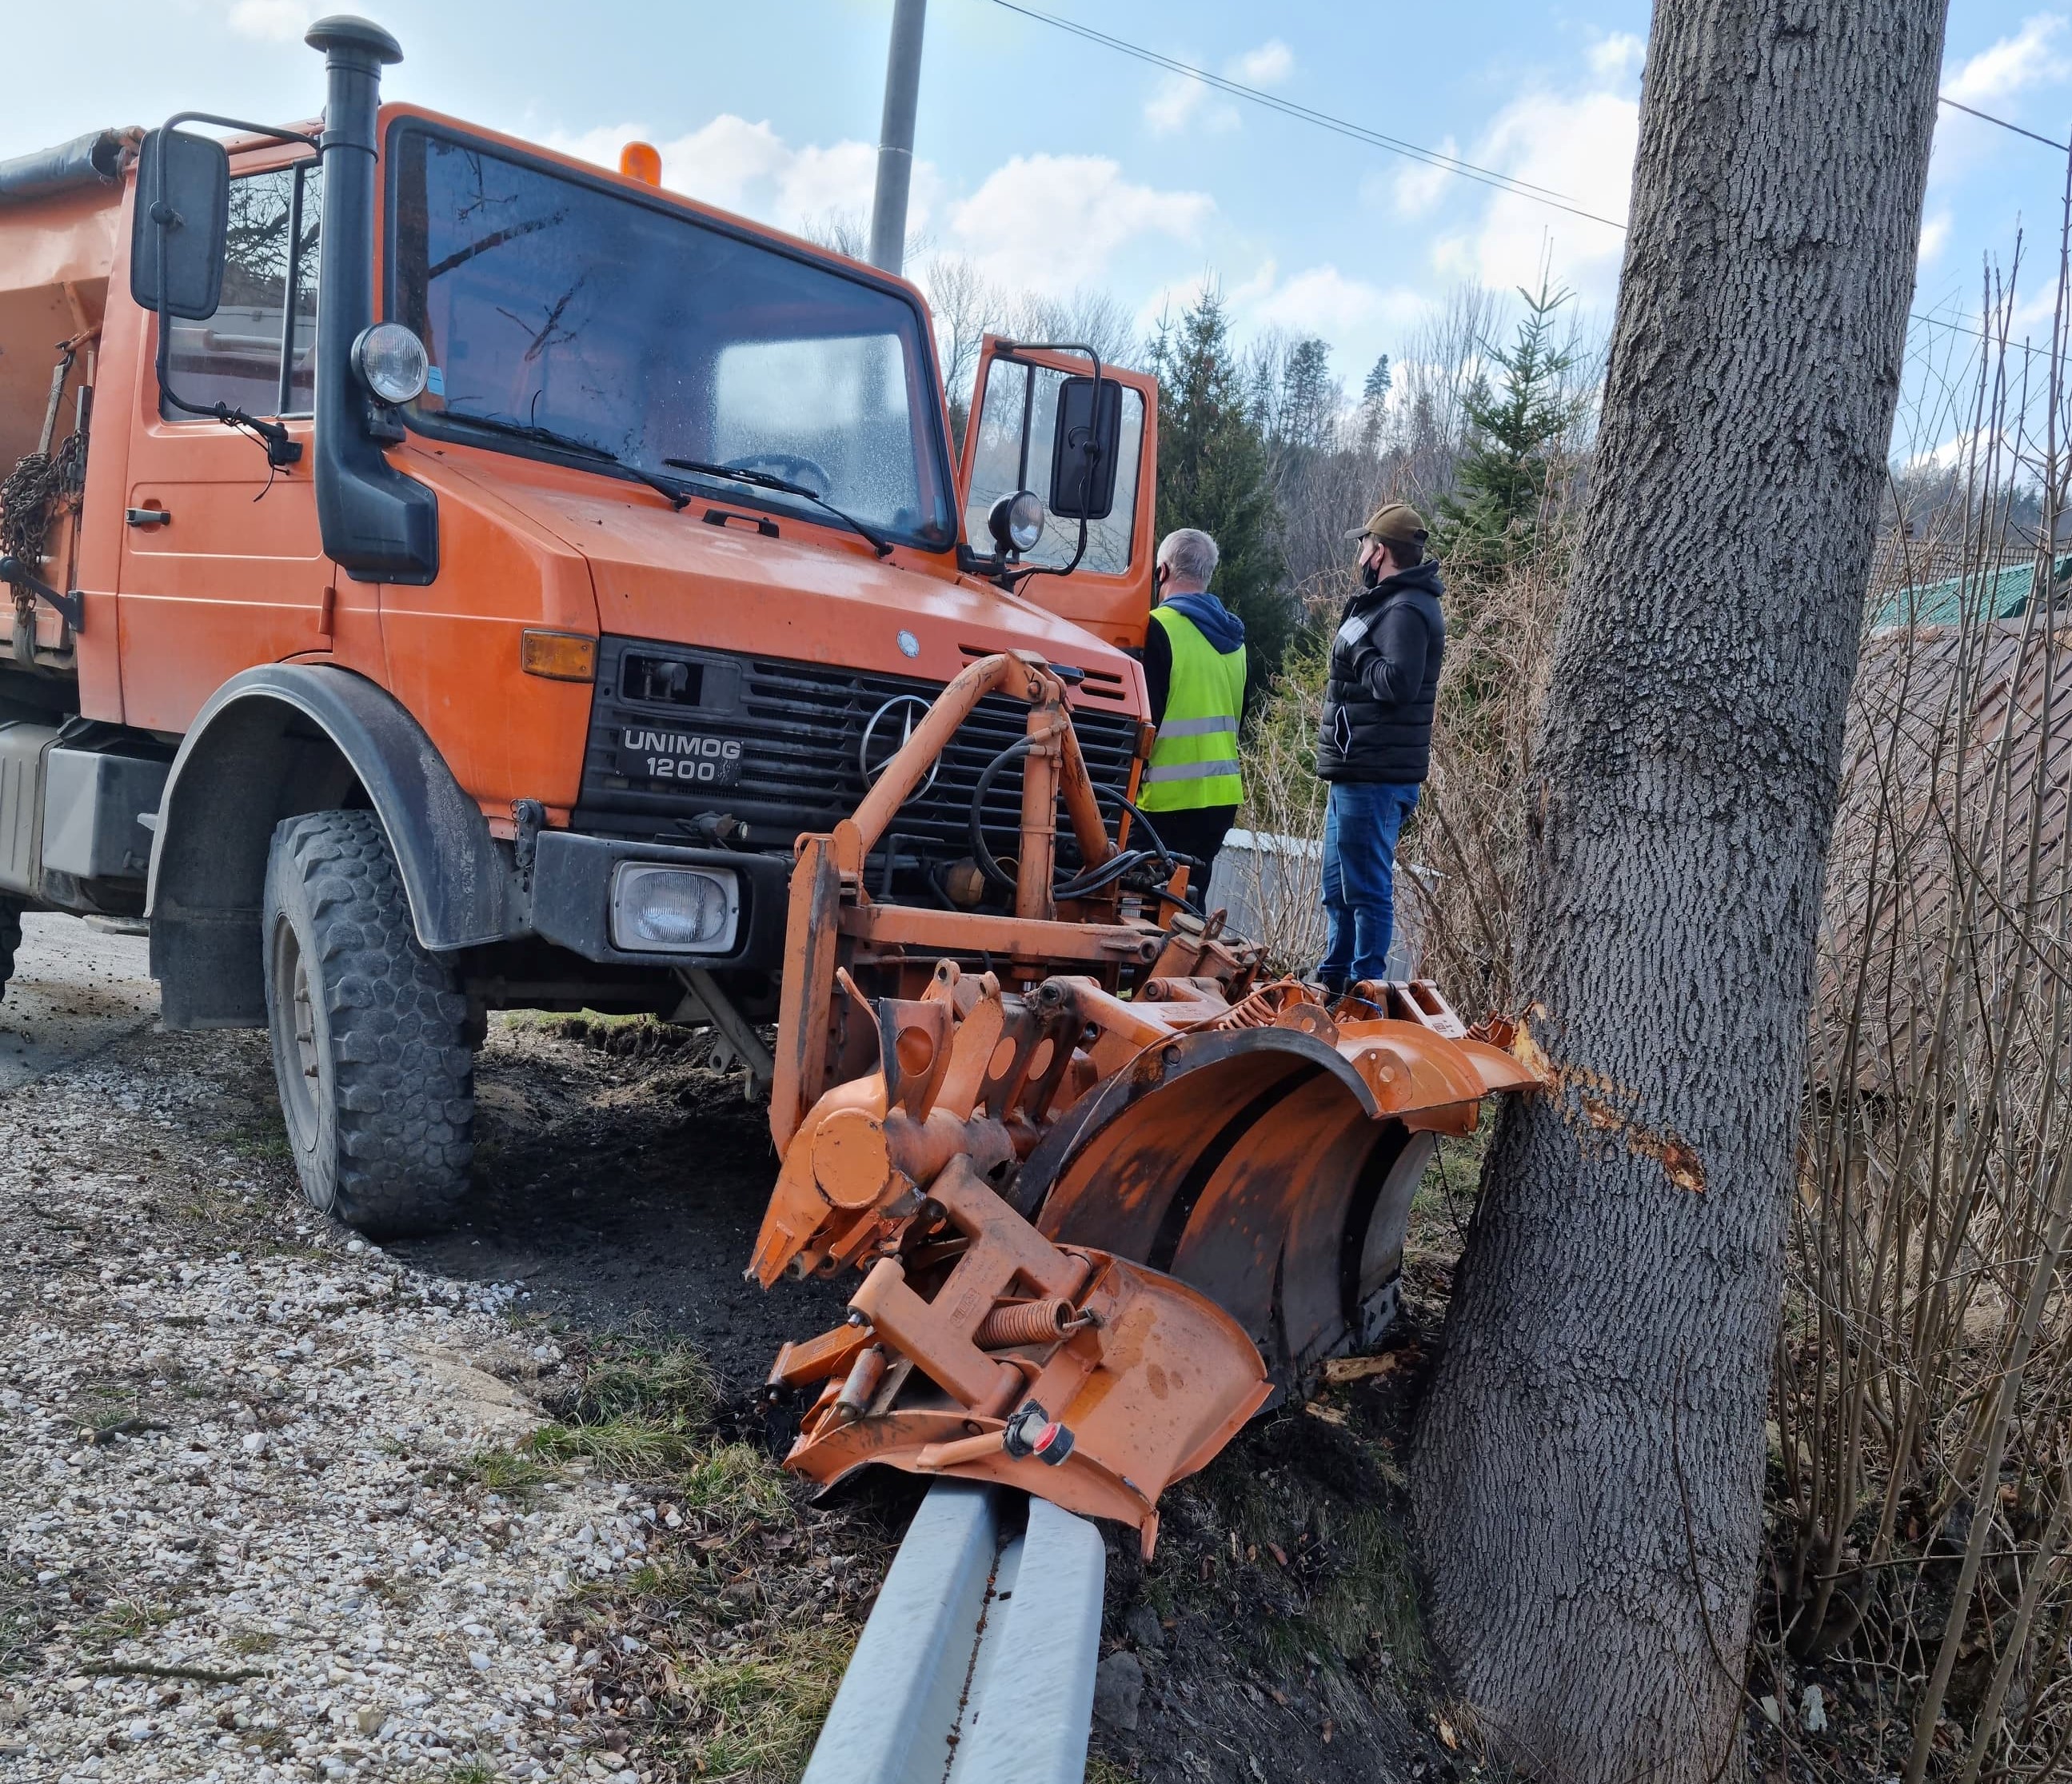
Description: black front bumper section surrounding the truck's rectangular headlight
xmin=533 ymin=831 xmax=792 ymax=972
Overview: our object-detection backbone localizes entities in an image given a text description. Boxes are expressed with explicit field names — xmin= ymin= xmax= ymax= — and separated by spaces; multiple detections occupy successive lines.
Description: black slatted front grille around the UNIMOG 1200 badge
xmin=576 ymin=638 xmax=1137 ymax=900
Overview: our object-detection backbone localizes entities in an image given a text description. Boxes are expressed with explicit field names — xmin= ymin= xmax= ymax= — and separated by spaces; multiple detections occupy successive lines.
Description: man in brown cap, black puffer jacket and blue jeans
xmin=1315 ymin=501 xmax=1447 ymax=992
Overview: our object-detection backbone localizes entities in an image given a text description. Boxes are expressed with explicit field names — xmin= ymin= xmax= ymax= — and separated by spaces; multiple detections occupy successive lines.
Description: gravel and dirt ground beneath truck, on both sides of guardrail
xmin=0 ymin=920 xmax=1482 ymax=1784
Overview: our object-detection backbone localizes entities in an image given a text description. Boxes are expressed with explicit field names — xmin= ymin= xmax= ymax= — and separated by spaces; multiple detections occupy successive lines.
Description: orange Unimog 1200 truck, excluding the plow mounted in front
xmin=0 ymin=18 xmax=1156 ymax=1233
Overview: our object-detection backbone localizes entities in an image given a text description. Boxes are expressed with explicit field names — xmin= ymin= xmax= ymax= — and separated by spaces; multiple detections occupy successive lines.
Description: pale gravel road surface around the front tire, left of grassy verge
xmin=0 ymin=918 xmax=814 ymax=1784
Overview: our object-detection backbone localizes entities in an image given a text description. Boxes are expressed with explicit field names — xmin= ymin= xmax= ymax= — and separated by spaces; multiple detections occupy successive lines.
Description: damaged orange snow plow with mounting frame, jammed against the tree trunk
xmin=748 ymin=659 xmax=1538 ymax=1554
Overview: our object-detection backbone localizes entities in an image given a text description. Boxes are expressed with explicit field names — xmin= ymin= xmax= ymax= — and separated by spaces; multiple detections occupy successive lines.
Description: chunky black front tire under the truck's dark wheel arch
xmin=261 ymin=812 xmax=474 ymax=1237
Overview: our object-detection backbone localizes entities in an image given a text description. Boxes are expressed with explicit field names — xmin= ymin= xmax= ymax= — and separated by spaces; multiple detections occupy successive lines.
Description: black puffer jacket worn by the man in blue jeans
xmin=1315 ymin=557 xmax=1447 ymax=785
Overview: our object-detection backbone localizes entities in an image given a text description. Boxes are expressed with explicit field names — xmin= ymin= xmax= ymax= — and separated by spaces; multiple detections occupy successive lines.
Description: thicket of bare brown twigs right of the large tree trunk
xmin=1751 ymin=257 xmax=2072 ymax=1784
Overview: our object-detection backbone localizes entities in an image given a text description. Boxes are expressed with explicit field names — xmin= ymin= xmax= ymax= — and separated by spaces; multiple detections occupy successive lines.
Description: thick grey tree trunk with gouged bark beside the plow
xmin=1415 ymin=0 xmax=1946 ymax=1784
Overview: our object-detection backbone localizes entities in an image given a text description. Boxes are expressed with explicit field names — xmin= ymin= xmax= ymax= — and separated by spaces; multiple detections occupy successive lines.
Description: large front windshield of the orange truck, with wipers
xmin=389 ymin=129 xmax=957 ymax=551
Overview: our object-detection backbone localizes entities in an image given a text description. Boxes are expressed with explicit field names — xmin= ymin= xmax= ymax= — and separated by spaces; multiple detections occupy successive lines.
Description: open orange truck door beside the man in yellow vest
xmin=957 ymin=333 xmax=1158 ymax=651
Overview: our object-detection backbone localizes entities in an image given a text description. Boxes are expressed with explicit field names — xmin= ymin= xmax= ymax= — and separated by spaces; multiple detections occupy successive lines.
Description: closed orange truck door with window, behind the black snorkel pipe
xmin=116 ymin=158 xmax=332 ymax=732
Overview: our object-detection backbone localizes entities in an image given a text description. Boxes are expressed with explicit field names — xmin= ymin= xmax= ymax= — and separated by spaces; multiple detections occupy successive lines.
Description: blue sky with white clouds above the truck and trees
xmin=0 ymin=0 xmax=2072 ymax=445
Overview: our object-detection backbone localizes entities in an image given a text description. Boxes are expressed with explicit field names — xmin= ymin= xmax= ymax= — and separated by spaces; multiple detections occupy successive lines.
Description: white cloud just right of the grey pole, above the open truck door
xmin=949 ymin=155 xmax=1216 ymax=294
